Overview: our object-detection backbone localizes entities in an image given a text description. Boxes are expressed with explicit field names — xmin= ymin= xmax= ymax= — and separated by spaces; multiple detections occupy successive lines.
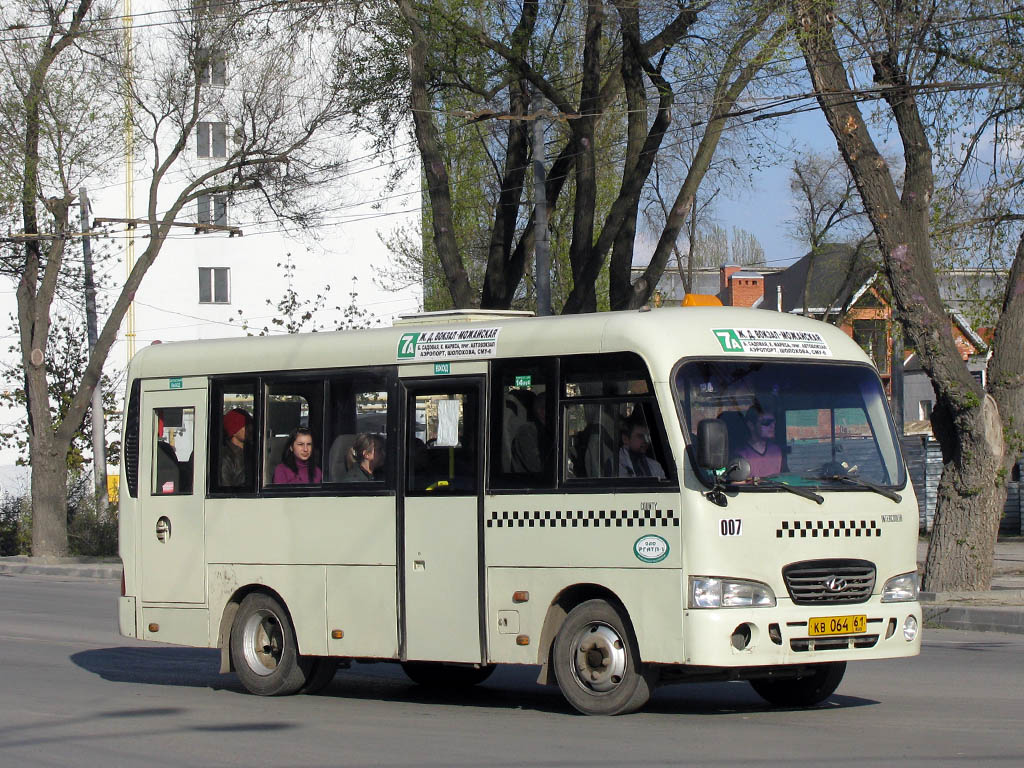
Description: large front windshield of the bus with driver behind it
xmin=674 ymin=360 xmax=905 ymax=487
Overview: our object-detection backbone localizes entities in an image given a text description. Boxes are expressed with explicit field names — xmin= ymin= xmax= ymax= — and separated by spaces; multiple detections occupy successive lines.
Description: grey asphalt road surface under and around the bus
xmin=0 ymin=575 xmax=1024 ymax=768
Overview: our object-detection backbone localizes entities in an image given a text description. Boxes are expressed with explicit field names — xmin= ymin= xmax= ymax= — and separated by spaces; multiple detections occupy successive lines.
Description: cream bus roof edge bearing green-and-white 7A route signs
xmin=123 ymin=307 xmax=870 ymax=380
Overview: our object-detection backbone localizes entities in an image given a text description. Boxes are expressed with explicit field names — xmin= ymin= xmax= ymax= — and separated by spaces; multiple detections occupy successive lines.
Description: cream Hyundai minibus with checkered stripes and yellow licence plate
xmin=119 ymin=307 xmax=921 ymax=715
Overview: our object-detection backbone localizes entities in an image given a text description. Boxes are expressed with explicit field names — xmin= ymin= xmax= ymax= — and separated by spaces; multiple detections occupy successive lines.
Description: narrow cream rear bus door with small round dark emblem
xmin=138 ymin=387 xmax=207 ymax=603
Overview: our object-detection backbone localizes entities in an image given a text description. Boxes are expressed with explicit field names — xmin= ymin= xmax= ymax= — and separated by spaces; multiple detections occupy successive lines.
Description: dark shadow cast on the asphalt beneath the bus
xmin=71 ymin=647 xmax=878 ymax=730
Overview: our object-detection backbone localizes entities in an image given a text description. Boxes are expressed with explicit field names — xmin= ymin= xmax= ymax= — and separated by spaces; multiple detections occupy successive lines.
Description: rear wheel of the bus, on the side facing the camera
xmin=230 ymin=592 xmax=314 ymax=696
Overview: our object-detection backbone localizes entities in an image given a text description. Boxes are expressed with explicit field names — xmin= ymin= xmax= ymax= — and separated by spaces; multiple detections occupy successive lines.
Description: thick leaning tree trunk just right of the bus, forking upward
xmin=793 ymin=0 xmax=1007 ymax=592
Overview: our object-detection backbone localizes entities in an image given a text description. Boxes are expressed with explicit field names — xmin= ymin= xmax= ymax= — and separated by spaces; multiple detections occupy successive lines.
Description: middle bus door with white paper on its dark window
xmin=401 ymin=377 xmax=484 ymax=664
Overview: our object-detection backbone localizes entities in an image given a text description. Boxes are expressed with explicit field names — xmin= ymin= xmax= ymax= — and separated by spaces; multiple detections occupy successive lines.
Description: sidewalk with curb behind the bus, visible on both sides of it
xmin=0 ymin=538 xmax=1024 ymax=634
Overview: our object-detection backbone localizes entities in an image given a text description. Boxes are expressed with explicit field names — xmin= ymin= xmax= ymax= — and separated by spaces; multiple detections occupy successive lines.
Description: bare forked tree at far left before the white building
xmin=0 ymin=0 xmax=356 ymax=555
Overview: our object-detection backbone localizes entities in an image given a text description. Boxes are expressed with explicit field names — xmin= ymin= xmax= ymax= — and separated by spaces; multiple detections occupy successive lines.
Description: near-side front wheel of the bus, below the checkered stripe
xmin=552 ymin=600 xmax=654 ymax=715
